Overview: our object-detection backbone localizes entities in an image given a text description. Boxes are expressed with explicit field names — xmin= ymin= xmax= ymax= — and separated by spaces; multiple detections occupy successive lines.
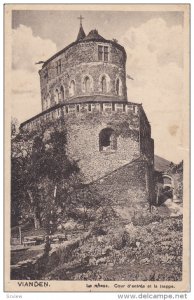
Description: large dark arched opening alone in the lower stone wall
xmin=99 ymin=128 xmax=117 ymax=151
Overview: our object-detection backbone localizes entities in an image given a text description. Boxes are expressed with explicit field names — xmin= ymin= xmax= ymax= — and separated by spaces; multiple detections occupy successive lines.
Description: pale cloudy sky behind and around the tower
xmin=12 ymin=11 xmax=184 ymax=162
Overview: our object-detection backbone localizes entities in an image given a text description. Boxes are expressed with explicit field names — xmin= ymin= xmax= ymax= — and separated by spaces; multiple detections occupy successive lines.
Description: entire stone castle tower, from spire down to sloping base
xmin=20 ymin=24 xmax=154 ymax=204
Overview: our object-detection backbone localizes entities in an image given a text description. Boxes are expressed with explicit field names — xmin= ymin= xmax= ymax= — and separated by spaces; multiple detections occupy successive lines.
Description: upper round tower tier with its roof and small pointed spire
xmin=39 ymin=25 xmax=127 ymax=111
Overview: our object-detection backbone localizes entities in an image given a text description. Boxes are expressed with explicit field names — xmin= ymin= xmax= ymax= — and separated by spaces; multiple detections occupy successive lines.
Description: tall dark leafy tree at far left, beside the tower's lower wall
xmin=11 ymin=129 xmax=79 ymax=227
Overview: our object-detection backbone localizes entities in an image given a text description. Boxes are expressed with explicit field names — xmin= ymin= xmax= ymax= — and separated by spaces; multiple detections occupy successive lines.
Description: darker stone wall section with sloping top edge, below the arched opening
xmin=93 ymin=159 xmax=150 ymax=207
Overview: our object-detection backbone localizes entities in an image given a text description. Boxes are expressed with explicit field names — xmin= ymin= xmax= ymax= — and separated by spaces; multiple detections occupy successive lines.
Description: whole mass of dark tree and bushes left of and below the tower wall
xmin=12 ymin=126 xmax=106 ymax=234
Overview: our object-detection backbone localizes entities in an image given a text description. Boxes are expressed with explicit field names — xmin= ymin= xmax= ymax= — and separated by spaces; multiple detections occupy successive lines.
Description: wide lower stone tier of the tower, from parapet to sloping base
xmin=18 ymin=103 xmax=154 ymax=205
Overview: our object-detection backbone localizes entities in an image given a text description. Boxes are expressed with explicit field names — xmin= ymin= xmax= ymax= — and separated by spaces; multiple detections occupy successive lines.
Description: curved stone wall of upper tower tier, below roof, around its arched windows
xmin=39 ymin=42 xmax=127 ymax=110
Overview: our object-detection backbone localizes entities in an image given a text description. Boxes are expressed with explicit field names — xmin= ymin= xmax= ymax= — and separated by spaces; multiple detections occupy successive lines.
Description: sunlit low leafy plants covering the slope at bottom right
xmin=43 ymin=214 xmax=182 ymax=281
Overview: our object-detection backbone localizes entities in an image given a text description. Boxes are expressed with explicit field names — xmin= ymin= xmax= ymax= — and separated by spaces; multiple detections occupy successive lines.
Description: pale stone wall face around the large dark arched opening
xmin=65 ymin=111 xmax=139 ymax=181
